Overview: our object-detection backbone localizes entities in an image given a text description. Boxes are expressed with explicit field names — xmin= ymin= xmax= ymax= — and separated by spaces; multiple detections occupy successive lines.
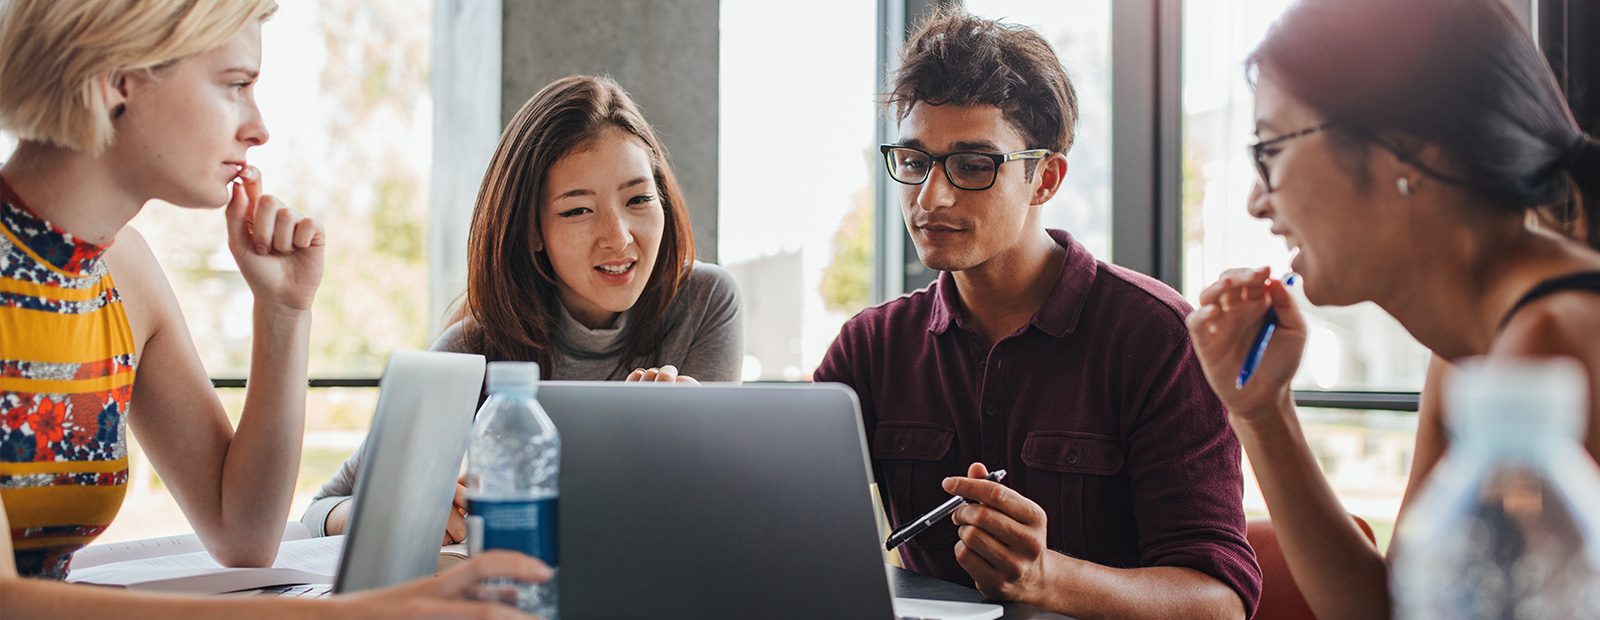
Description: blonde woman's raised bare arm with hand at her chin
xmin=106 ymin=168 xmax=323 ymax=566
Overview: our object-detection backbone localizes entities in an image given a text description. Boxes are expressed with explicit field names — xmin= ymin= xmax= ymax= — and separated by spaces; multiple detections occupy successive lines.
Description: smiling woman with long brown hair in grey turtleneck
xmin=302 ymin=75 xmax=744 ymax=543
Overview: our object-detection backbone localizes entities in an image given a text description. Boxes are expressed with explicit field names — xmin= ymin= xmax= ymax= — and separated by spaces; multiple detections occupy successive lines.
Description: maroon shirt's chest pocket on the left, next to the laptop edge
xmin=870 ymin=422 xmax=965 ymax=546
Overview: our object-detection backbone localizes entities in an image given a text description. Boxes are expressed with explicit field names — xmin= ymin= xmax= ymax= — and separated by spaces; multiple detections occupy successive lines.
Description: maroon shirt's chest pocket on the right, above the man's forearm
xmin=1022 ymin=431 xmax=1133 ymax=558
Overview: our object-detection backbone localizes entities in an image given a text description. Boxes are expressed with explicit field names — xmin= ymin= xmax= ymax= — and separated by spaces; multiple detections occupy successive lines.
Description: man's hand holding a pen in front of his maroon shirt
xmin=944 ymin=463 xmax=1051 ymax=601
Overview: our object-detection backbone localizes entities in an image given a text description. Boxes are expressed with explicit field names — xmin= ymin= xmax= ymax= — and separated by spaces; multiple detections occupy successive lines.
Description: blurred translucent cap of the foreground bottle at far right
xmin=1445 ymin=356 xmax=1589 ymax=441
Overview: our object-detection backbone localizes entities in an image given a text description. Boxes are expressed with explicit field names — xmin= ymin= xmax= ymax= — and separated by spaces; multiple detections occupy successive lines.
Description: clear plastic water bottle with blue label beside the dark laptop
xmin=467 ymin=361 xmax=562 ymax=620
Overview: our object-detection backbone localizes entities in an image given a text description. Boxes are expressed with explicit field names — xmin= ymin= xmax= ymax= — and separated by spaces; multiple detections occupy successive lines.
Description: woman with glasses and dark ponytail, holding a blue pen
xmin=1189 ymin=0 xmax=1600 ymax=618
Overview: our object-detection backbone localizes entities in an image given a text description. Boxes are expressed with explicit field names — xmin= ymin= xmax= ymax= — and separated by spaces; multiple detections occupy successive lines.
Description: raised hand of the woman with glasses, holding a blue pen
xmin=1187 ymin=267 xmax=1307 ymax=420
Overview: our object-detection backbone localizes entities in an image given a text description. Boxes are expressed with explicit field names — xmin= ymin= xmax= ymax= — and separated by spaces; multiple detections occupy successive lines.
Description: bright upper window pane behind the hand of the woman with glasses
xmin=1182 ymin=0 xmax=1427 ymax=390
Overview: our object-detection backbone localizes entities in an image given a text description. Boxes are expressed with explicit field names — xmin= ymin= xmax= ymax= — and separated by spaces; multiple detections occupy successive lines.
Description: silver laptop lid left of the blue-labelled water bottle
xmin=333 ymin=352 xmax=485 ymax=593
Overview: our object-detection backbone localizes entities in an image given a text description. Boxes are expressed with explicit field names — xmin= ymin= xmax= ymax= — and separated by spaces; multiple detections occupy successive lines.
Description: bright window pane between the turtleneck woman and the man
xmin=717 ymin=0 xmax=880 ymax=380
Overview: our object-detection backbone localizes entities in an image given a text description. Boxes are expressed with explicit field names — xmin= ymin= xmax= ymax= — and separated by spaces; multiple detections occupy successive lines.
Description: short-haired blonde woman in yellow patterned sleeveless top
xmin=0 ymin=0 xmax=549 ymax=618
